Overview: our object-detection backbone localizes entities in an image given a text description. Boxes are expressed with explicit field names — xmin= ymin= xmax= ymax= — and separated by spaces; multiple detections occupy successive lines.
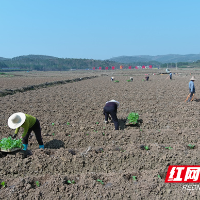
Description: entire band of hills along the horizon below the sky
xmin=0 ymin=54 xmax=200 ymax=71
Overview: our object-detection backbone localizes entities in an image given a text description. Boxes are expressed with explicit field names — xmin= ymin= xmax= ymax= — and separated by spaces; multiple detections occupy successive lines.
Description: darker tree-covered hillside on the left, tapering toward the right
xmin=0 ymin=55 xmax=159 ymax=71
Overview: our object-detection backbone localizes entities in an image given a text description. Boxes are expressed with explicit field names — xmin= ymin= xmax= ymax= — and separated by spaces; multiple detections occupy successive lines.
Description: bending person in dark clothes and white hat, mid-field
xmin=103 ymin=100 xmax=119 ymax=130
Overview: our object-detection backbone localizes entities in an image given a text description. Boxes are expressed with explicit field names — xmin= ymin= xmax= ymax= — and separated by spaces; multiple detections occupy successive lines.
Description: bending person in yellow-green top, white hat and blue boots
xmin=8 ymin=112 xmax=44 ymax=151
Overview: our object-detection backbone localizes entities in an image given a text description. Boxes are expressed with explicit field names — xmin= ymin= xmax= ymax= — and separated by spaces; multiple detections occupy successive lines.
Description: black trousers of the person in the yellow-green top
xmin=23 ymin=119 xmax=43 ymax=145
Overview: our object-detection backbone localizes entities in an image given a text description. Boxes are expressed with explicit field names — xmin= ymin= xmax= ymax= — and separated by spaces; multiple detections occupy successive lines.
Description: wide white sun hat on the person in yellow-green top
xmin=8 ymin=112 xmax=26 ymax=129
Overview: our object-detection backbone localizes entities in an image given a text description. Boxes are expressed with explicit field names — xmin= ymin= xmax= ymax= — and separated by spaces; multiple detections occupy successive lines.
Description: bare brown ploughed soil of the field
xmin=0 ymin=70 xmax=200 ymax=200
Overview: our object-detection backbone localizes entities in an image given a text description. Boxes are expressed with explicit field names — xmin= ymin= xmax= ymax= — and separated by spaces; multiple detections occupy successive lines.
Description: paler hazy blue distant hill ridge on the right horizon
xmin=109 ymin=54 xmax=200 ymax=63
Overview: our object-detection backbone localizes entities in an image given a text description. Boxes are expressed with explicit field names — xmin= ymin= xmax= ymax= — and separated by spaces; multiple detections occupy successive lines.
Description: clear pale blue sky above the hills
xmin=0 ymin=0 xmax=200 ymax=60
